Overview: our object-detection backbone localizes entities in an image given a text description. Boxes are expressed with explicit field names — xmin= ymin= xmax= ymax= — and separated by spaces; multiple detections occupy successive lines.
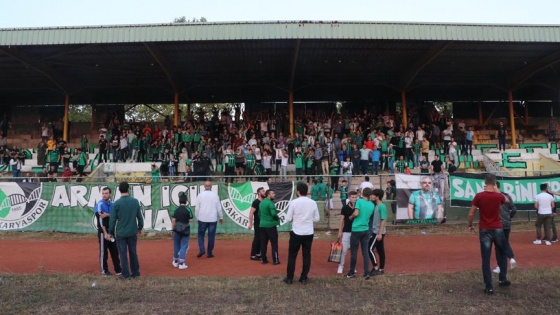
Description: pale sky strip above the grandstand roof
xmin=0 ymin=0 xmax=560 ymax=28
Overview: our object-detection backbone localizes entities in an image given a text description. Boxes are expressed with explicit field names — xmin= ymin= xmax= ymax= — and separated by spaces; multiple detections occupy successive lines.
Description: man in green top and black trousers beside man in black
xmin=259 ymin=189 xmax=280 ymax=265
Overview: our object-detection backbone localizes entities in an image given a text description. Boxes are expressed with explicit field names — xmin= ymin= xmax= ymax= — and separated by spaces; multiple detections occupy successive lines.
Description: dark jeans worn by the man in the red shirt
xmin=478 ymin=229 xmax=507 ymax=289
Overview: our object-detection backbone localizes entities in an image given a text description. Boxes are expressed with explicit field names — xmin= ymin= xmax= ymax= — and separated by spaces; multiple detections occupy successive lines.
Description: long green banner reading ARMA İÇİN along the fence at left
xmin=0 ymin=182 xmax=296 ymax=233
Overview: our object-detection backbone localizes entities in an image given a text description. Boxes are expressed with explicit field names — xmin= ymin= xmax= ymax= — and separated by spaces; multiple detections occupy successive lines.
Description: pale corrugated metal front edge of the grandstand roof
xmin=0 ymin=21 xmax=560 ymax=46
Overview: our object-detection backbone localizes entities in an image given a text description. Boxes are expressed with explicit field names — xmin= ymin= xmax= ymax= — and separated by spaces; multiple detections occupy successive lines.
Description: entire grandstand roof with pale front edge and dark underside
xmin=0 ymin=22 xmax=560 ymax=106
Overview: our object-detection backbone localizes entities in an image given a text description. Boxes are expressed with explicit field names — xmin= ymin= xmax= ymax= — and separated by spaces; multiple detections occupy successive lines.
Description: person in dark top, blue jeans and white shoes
xmin=171 ymin=192 xmax=193 ymax=269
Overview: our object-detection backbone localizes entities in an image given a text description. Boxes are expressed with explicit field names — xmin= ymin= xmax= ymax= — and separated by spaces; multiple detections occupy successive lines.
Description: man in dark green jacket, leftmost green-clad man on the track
xmin=108 ymin=182 xmax=144 ymax=279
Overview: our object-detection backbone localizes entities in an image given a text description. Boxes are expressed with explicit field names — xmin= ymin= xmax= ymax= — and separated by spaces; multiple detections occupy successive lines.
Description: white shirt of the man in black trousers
xmin=285 ymin=196 xmax=320 ymax=235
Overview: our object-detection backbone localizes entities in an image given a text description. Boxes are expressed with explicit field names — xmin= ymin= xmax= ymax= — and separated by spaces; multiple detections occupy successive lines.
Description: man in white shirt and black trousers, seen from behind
xmin=284 ymin=182 xmax=320 ymax=284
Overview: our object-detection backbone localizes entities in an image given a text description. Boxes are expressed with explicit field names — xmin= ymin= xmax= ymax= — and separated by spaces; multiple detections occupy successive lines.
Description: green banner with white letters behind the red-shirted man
xmin=449 ymin=173 xmax=560 ymax=210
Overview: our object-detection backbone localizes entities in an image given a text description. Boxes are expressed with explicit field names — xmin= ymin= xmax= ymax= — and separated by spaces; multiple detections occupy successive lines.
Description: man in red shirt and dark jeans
xmin=469 ymin=174 xmax=511 ymax=295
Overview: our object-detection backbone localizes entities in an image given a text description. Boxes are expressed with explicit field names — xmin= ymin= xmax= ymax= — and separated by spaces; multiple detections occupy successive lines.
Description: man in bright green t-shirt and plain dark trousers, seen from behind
xmin=346 ymin=188 xmax=375 ymax=280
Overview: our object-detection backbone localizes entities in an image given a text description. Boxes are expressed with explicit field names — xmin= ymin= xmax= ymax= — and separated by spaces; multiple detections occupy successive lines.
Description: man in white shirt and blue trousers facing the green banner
xmin=195 ymin=181 xmax=224 ymax=258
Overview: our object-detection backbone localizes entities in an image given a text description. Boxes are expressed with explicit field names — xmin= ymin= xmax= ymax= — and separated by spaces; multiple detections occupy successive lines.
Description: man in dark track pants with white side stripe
xmin=369 ymin=189 xmax=387 ymax=276
